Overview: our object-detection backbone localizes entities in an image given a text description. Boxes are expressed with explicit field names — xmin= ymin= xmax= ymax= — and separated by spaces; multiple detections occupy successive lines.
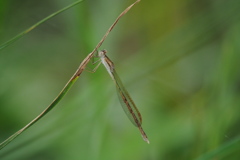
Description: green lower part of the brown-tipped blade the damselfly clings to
xmin=0 ymin=76 xmax=79 ymax=150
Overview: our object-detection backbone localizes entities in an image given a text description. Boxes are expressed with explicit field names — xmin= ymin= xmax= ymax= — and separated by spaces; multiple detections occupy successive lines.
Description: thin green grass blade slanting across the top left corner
xmin=0 ymin=0 xmax=83 ymax=50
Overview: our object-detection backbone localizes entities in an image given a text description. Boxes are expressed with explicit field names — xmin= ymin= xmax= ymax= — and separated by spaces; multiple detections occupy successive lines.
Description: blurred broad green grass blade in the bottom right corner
xmin=197 ymin=137 xmax=240 ymax=160
